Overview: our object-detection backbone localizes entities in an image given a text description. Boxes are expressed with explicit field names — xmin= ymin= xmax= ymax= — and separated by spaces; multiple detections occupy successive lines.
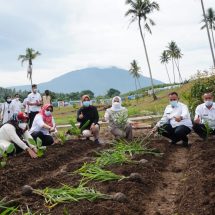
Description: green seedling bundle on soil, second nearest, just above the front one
xmin=74 ymin=163 xmax=127 ymax=184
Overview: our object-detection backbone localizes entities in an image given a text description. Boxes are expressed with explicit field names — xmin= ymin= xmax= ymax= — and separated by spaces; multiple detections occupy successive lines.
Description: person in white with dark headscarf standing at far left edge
xmin=0 ymin=96 xmax=15 ymax=124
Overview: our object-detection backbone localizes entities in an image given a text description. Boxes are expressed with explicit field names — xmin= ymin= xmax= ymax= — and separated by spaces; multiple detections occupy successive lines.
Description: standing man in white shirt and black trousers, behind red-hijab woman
xmin=27 ymin=84 xmax=42 ymax=128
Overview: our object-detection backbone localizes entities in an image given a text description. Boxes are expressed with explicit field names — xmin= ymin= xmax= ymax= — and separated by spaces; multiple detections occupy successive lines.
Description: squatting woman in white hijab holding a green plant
xmin=104 ymin=96 xmax=132 ymax=140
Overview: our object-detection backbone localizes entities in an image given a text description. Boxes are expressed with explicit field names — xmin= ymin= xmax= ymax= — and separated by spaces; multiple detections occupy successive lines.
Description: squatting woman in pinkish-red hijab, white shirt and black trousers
xmin=30 ymin=104 xmax=56 ymax=146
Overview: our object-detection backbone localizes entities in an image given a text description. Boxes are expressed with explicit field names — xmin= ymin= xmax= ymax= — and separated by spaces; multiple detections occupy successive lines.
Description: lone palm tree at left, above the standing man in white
xmin=18 ymin=48 xmax=41 ymax=86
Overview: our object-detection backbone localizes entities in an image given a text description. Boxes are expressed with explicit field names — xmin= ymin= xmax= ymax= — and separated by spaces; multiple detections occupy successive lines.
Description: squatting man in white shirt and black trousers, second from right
xmin=153 ymin=92 xmax=192 ymax=147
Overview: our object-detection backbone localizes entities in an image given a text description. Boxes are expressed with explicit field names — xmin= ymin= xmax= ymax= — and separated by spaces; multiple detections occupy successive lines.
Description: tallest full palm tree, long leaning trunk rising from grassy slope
xmin=125 ymin=0 xmax=159 ymax=100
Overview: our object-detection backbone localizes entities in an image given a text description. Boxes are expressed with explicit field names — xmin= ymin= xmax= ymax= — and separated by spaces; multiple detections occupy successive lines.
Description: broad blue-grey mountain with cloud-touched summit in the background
xmin=10 ymin=67 xmax=163 ymax=95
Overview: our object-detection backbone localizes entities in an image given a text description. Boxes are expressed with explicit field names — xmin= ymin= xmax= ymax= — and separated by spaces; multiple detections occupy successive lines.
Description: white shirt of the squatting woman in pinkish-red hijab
xmin=30 ymin=114 xmax=55 ymax=135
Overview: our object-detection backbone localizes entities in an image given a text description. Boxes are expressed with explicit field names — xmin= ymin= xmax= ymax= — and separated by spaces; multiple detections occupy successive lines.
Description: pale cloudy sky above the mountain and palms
xmin=0 ymin=0 xmax=215 ymax=87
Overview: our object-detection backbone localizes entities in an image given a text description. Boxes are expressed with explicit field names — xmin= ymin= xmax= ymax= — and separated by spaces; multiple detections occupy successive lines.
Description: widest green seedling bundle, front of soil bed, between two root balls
xmin=33 ymin=184 xmax=110 ymax=208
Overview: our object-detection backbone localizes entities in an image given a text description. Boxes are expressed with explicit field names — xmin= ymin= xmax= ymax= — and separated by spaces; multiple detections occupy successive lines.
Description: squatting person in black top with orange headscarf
xmin=77 ymin=95 xmax=99 ymax=144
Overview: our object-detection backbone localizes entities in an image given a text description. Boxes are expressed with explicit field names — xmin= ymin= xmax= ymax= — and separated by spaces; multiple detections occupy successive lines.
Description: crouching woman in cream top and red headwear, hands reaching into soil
xmin=0 ymin=112 xmax=37 ymax=158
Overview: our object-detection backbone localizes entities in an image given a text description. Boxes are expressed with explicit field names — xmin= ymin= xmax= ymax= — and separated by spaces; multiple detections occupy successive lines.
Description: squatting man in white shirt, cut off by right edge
xmin=193 ymin=93 xmax=215 ymax=140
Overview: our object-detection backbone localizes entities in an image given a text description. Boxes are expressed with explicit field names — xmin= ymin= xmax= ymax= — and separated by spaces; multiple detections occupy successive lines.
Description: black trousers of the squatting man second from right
xmin=158 ymin=124 xmax=191 ymax=143
